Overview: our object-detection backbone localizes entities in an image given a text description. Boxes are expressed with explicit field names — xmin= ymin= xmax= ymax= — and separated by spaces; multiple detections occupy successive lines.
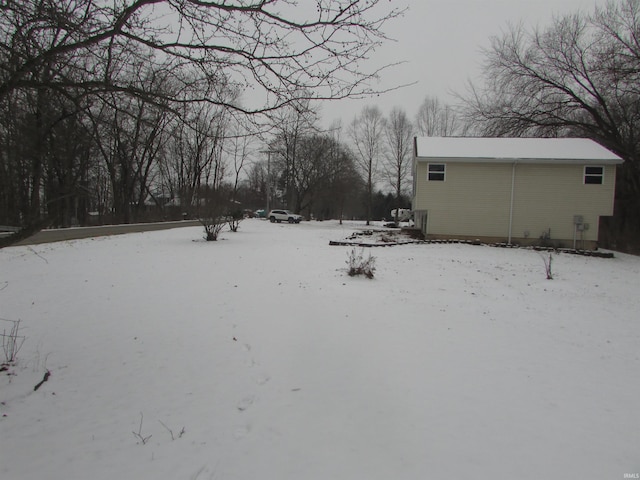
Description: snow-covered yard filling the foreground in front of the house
xmin=0 ymin=219 xmax=640 ymax=480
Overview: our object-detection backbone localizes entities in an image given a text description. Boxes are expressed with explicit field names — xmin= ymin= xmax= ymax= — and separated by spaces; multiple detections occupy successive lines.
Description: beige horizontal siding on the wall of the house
xmin=413 ymin=161 xmax=615 ymax=246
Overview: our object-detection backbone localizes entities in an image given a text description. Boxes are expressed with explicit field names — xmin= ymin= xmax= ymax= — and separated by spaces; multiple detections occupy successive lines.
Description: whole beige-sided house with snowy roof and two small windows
xmin=413 ymin=137 xmax=622 ymax=249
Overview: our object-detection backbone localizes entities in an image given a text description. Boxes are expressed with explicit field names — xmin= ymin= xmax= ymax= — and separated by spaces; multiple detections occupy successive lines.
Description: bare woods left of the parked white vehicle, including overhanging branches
xmin=0 ymin=0 xmax=402 ymax=240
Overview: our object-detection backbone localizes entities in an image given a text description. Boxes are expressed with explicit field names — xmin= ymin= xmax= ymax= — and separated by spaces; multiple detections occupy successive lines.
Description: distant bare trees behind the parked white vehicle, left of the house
xmin=248 ymin=96 xmax=464 ymax=224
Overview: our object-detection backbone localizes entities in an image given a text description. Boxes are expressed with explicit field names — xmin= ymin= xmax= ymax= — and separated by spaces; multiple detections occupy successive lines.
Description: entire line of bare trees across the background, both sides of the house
xmin=0 ymin=0 xmax=640 ymax=249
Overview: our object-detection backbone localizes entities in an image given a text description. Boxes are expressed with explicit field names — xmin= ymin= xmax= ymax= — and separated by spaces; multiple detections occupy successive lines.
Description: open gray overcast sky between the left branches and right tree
xmin=322 ymin=0 xmax=606 ymax=126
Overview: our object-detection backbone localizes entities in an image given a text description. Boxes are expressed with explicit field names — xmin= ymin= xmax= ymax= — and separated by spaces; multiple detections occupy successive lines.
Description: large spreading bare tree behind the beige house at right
xmin=466 ymin=0 xmax=640 ymax=251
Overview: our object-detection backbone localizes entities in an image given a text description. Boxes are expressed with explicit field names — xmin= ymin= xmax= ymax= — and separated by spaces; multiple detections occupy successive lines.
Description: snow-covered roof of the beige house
xmin=414 ymin=137 xmax=623 ymax=164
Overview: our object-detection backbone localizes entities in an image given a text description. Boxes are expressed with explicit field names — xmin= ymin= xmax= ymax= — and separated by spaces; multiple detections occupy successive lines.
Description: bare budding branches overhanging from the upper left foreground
xmin=0 ymin=0 xmax=402 ymax=113
